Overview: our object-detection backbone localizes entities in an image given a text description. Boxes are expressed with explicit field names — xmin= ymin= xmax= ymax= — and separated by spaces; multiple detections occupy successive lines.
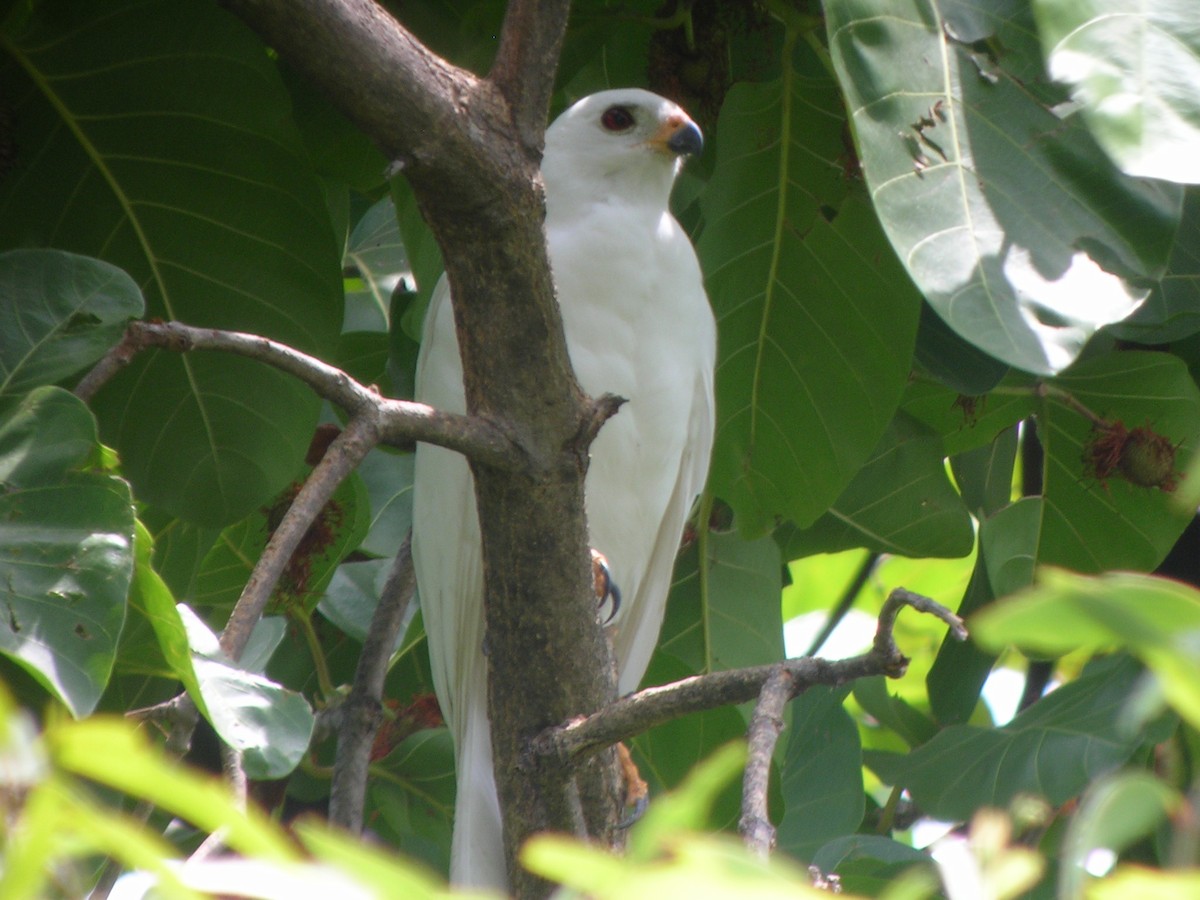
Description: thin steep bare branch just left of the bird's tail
xmin=329 ymin=535 xmax=415 ymax=834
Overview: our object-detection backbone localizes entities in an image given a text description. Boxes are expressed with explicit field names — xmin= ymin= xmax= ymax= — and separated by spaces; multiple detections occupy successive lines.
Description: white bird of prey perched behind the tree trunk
xmin=413 ymin=89 xmax=716 ymax=888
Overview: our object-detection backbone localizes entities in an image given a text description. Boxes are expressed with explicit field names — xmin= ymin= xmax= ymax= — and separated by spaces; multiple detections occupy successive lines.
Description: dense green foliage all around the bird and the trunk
xmin=0 ymin=0 xmax=1200 ymax=898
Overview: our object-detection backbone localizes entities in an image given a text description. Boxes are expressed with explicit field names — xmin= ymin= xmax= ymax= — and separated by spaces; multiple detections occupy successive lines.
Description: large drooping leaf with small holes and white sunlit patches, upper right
xmin=826 ymin=0 xmax=1182 ymax=373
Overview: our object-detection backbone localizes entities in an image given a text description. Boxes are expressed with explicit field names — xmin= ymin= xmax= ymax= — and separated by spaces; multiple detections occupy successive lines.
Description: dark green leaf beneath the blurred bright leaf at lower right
xmin=864 ymin=657 xmax=1144 ymax=821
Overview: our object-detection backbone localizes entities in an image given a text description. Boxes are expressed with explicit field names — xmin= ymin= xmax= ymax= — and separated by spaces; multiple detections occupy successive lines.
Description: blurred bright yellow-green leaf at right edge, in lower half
xmin=971 ymin=569 xmax=1200 ymax=727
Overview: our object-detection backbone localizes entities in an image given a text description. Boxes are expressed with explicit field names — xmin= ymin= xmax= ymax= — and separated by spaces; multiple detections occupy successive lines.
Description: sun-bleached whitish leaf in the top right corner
xmin=1033 ymin=0 xmax=1200 ymax=184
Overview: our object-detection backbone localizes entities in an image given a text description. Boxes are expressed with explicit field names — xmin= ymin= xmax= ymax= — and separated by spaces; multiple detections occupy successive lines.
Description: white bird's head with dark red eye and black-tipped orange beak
xmin=541 ymin=88 xmax=704 ymax=216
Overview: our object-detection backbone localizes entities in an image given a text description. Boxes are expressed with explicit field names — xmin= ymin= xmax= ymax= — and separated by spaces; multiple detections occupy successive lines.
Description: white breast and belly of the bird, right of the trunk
xmin=546 ymin=196 xmax=715 ymax=662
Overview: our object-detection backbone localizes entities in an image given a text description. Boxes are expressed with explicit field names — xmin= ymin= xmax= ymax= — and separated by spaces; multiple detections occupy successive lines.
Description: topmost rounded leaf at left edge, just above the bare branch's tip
xmin=0 ymin=250 xmax=143 ymax=395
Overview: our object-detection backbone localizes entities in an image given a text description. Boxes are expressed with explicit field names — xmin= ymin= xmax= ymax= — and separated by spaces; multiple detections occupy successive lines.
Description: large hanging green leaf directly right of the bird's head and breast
xmin=697 ymin=40 xmax=920 ymax=534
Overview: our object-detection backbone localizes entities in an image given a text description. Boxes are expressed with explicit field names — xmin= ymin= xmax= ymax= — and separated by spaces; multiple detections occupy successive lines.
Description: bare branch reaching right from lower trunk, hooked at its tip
xmin=527 ymin=588 xmax=967 ymax=766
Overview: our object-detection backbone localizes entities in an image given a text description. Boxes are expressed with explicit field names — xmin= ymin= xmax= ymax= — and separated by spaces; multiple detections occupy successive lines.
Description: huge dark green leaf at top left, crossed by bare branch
xmin=0 ymin=0 xmax=342 ymax=524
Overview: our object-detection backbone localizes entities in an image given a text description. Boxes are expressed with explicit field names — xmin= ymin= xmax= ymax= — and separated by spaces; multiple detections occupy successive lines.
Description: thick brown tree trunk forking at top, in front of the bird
xmin=224 ymin=0 xmax=619 ymax=896
